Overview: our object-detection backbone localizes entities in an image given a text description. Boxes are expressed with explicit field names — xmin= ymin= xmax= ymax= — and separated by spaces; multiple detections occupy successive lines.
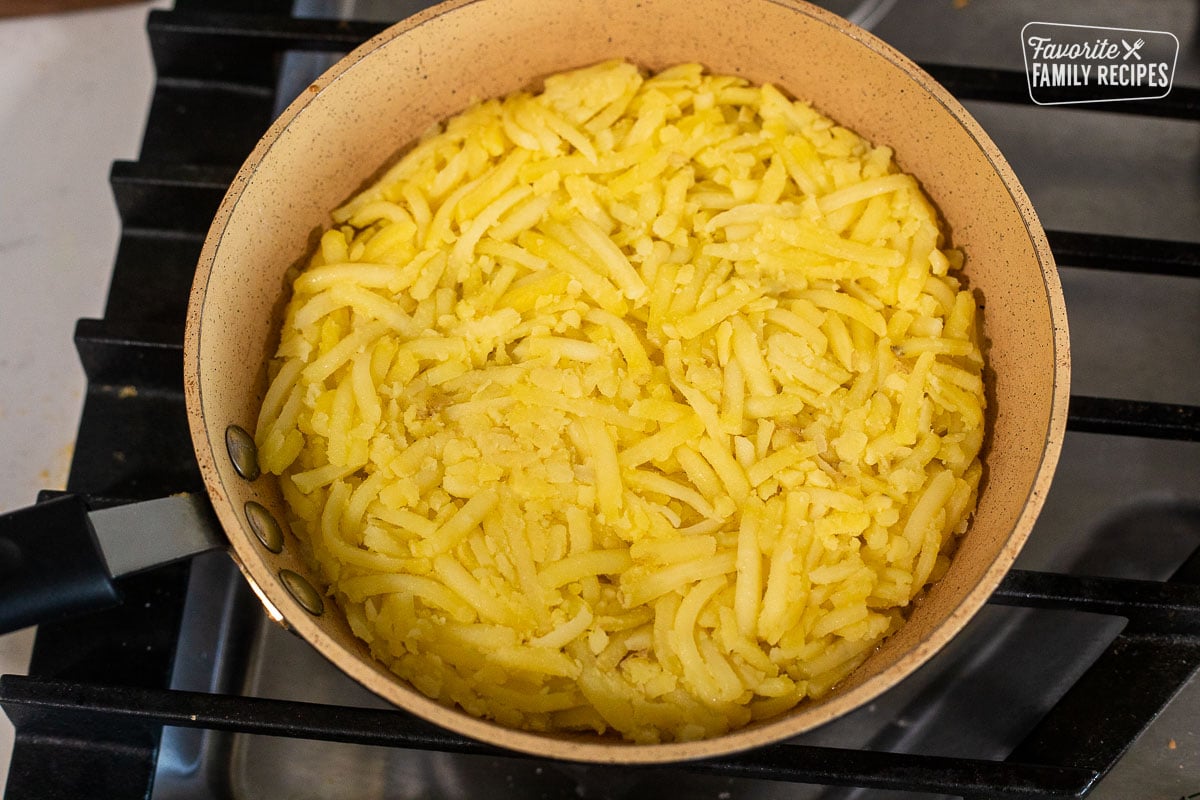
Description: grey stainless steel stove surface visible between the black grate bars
xmin=2 ymin=0 xmax=1200 ymax=800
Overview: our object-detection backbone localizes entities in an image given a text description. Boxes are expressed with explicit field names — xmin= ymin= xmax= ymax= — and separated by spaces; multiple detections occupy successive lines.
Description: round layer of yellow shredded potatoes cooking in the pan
xmin=256 ymin=62 xmax=984 ymax=742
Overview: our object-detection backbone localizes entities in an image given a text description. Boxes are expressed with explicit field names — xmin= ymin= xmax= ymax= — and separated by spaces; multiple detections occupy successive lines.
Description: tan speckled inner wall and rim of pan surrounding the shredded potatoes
xmin=185 ymin=0 xmax=1069 ymax=763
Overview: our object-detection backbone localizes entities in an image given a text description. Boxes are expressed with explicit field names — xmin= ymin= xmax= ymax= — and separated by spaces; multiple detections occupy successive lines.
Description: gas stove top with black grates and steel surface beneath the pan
xmin=0 ymin=0 xmax=1200 ymax=800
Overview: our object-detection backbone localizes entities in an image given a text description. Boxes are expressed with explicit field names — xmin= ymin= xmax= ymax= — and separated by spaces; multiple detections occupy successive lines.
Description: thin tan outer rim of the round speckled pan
xmin=184 ymin=0 xmax=1070 ymax=764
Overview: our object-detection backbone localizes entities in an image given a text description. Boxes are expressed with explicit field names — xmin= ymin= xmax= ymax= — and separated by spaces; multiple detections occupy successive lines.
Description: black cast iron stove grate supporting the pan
xmin=0 ymin=0 xmax=1200 ymax=800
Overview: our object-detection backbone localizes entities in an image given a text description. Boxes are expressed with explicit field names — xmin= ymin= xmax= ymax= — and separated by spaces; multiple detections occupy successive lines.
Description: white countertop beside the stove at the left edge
xmin=0 ymin=2 xmax=166 ymax=794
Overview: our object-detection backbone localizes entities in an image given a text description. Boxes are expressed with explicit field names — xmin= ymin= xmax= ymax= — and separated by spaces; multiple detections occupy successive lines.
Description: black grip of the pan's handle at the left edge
xmin=0 ymin=494 xmax=121 ymax=633
